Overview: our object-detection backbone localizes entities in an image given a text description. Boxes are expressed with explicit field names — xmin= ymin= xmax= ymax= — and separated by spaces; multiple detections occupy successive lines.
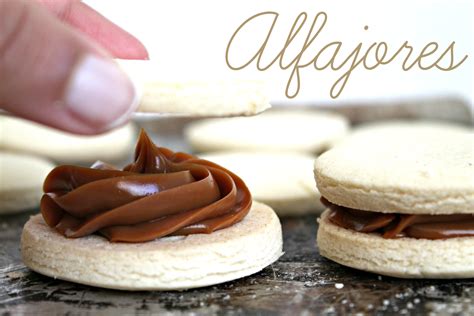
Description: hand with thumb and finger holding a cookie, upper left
xmin=0 ymin=0 xmax=148 ymax=134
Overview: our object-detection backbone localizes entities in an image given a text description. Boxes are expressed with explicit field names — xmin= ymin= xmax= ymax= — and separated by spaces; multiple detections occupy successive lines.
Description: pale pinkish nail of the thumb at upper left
xmin=64 ymin=55 xmax=138 ymax=130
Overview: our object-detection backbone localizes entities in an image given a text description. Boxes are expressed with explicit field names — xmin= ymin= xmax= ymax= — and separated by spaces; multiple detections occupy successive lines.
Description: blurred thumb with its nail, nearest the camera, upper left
xmin=0 ymin=1 xmax=137 ymax=134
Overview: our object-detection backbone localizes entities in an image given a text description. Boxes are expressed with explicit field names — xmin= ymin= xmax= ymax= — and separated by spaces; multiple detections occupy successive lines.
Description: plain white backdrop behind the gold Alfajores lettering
xmin=85 ymin=0 xmax=474 ymax=105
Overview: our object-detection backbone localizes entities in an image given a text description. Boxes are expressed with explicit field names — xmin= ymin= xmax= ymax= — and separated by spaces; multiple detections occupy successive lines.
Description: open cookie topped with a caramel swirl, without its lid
xmin=21 ymin=131 xmax=282 ymax=290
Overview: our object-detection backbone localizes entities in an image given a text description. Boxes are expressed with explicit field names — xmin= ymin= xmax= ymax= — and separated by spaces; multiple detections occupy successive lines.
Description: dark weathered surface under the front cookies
xmin=0 ymin=209 xmax=474 ymax=315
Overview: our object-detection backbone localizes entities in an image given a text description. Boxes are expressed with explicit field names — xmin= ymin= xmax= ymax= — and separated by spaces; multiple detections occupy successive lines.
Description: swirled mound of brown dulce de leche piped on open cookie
xmin=41 ymin=131 xmax=252 ymax=242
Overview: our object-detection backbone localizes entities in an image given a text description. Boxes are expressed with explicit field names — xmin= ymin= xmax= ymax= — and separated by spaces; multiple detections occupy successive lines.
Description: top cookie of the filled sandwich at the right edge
xmin=314 ymin=122 xmax=474 ymax=214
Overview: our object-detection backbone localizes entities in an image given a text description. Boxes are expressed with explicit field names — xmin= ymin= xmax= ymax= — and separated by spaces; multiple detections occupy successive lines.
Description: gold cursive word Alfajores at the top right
xmin=225 ymin=11 xmax=468 ymax=99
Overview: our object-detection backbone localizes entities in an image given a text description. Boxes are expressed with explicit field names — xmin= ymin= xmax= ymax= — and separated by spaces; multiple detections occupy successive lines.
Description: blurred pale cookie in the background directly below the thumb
xmin=0 ymin=117 xmax=136 ymax=163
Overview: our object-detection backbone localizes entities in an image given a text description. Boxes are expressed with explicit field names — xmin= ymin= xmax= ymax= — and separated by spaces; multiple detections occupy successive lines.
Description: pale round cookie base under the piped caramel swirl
xmin=21 ymin=202 xmax=283 ymax=291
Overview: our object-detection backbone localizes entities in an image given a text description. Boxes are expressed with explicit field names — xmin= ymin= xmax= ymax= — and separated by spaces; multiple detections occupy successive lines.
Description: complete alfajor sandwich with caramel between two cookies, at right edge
xmin=314 ymin=122 xmax=474 ymax=278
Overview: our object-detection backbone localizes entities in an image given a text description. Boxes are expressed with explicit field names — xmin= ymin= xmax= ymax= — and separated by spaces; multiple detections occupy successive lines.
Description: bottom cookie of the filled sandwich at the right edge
xmin=317 ymin=210 xmax=474 ymax=279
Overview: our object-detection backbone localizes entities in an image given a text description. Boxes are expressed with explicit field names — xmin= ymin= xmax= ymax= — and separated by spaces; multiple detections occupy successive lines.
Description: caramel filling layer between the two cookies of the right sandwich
xmin=321 ymin=198 xmax=474 ymax=239
